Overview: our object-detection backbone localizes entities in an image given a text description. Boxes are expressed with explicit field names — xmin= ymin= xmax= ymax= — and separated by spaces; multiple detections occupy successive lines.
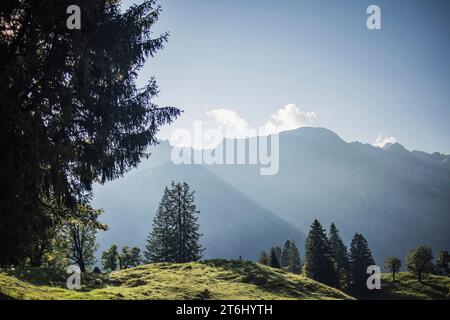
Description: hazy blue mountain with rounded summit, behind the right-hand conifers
xmin=208 ymin=128 xmax=450 ymax=264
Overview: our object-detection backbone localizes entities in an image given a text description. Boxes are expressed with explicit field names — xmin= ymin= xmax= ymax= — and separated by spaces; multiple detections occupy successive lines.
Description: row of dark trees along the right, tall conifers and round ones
xmin=259 ymin=220 xmax=450 ymax=293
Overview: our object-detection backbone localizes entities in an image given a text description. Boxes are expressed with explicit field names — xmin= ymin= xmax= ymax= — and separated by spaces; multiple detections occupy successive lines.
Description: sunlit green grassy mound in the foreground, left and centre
xmin=0 ymin=260 xmax=351 ymax=300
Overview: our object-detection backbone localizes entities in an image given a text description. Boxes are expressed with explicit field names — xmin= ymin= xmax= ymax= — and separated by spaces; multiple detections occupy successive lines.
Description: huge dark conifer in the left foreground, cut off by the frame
xmin=0 ymin=0 xmax=180 ymax=265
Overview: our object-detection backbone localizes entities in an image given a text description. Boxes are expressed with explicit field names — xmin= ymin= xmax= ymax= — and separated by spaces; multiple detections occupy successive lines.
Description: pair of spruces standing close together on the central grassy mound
xmin=144 ymin=182 xmax=203 ymax=262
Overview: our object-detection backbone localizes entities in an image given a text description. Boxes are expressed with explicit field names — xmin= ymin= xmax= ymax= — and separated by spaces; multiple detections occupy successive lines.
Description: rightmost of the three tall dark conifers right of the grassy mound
xmin=350 ymin=233 xmax=375 ymax=292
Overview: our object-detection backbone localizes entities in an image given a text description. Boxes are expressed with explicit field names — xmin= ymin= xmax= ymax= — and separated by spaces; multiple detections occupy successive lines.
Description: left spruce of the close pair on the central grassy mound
xmin=144 ymin=187 xmax=175 ymax=263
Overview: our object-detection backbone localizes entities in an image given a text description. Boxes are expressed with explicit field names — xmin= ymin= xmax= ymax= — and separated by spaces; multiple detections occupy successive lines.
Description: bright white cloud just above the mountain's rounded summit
xmin=259 ymin=103 xmax=317 ymax=135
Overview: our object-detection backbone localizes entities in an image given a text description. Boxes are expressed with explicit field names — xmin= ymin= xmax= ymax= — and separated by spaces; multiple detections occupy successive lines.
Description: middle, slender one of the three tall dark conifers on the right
xmin=328 ymin=223 xmax=350 ymax=288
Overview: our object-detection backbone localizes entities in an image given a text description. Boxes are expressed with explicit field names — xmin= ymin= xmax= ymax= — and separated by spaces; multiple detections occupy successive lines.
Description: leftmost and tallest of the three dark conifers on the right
xmin=304 ymin=220 xmax=338 ymax=287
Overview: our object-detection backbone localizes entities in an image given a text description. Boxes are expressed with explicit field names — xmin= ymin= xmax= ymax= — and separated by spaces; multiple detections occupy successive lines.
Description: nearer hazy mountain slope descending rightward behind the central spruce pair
xmin=92 ymin=142 xmax=304 ymax=259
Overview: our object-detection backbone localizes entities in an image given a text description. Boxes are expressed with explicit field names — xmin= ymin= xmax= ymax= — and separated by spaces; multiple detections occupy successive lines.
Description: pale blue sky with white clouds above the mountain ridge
xmin=122 ymin=0 xmax=450 ymax=154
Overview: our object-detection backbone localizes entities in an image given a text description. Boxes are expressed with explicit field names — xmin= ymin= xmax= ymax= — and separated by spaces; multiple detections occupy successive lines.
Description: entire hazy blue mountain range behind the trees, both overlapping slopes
xmin=93 ymin=128 xmax=450 ymax=265
